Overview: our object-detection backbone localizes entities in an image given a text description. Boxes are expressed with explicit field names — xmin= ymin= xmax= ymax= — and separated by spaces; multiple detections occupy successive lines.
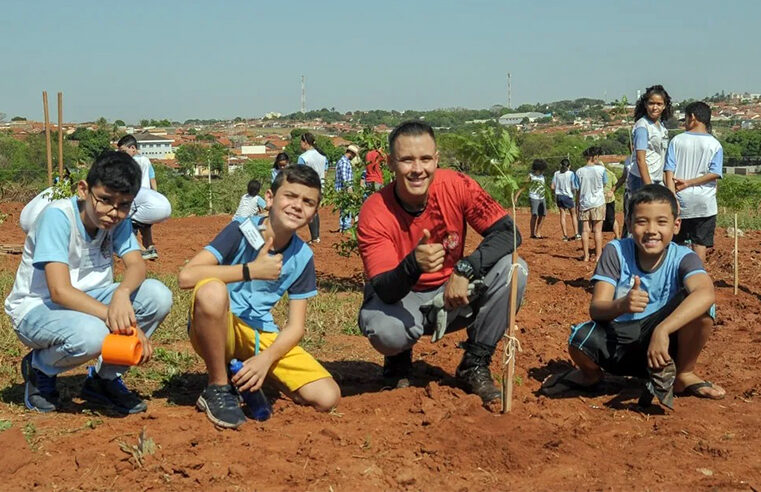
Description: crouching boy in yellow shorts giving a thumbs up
xmin=179 ymin=166 xmax=341 ymax=428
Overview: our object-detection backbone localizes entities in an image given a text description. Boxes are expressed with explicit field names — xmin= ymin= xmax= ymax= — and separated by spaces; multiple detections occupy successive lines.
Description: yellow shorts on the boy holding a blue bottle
xmin=188 ymin=278 xmax=332 ymax=391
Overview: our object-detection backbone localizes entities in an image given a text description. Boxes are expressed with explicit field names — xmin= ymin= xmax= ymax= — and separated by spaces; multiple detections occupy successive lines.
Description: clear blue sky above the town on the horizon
xmin=0 ymin=0 xmax=761 ymax=123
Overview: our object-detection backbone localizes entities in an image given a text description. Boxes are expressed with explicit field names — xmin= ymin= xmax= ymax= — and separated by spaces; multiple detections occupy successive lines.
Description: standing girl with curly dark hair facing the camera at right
xmin=629 ymin=85 xmax=672 ymax=193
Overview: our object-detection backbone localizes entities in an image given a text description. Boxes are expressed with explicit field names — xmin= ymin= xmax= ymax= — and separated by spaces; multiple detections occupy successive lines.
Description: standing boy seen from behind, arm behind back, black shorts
xmin=664 ymin=102 xmax=724 ymax=262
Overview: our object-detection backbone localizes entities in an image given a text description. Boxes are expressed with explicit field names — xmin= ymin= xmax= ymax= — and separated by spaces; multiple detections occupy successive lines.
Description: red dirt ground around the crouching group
xmin=0 ymin=204 xmax=761 ymax=491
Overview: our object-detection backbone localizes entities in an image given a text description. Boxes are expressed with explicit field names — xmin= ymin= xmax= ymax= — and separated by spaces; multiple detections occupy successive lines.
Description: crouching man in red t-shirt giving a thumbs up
xmin=358 ymin=121 xmax=527 ymax=403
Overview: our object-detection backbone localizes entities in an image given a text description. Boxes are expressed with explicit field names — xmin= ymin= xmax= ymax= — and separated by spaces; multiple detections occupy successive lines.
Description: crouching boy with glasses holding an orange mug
xmin=5 ymin=152 xmax=172 ymax=413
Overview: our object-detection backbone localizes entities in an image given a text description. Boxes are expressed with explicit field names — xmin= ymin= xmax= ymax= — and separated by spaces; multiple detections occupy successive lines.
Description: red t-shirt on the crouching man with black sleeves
xmin=357 ymin=169 xmax=507 ymax=291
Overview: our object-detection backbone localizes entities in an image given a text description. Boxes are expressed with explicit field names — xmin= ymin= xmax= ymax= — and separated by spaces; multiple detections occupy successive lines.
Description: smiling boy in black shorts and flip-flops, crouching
xmin=542 ymin=185 xmax=725 ymax=406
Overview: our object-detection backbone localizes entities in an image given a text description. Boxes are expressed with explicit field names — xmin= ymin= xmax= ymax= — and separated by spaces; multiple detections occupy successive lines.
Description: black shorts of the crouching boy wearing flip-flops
xmin=568 ymin=290 xmax=714 ymax=378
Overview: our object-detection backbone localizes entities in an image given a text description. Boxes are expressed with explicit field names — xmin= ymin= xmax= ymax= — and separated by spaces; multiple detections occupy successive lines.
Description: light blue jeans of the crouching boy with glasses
xmin=16 ymin=279 xmax=172 ymax=379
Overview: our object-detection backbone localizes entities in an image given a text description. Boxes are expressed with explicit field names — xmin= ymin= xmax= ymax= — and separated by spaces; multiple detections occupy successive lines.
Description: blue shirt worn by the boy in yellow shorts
xmin=204 ymin=216 xmax=317 ymax=332
